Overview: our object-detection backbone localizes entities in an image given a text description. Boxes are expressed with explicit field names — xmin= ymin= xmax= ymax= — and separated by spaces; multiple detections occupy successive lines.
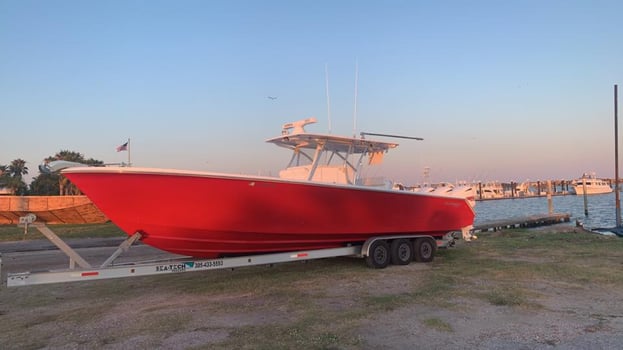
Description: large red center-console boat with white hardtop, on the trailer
xmin=62 ymin=118 xmax=474 ymax=258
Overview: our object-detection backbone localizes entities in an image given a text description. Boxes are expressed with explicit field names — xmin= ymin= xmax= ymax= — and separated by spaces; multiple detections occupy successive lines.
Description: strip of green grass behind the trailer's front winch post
xmin=0 ymin=222 xmax=125 ymax=242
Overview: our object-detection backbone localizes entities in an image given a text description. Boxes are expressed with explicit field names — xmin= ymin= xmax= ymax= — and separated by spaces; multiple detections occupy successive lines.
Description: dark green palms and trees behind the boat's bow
xmin=0 ymin=150 xmax=104 ymax=196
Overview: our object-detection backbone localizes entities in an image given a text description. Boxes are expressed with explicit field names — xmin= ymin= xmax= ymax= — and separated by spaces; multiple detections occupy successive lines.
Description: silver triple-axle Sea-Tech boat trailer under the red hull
xmin=0 ymin=214 xmax=454 ymax=287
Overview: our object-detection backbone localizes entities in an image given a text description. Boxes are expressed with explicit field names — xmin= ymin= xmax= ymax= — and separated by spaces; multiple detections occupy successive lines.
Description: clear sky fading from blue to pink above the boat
xmin=0 ymin=0 xmax=623 ymax=184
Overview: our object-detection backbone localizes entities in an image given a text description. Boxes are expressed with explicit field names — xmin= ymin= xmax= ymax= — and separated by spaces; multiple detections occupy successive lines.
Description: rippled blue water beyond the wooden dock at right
xmin=474 ymin=192 xmax=616 ymax=229
